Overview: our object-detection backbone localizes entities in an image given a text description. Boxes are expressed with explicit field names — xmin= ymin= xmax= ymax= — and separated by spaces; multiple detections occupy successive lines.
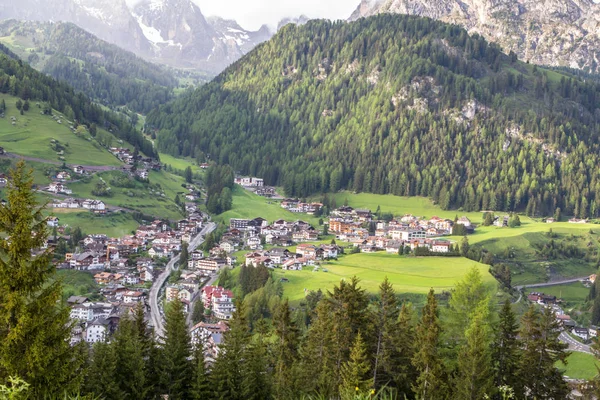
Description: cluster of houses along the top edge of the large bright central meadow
xmin=328 ymin=206 xmax=458 ymax=253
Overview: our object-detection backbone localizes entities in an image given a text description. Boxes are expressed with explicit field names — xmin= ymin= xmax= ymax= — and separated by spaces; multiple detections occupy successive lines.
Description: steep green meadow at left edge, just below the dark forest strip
xmin=0 ymin=94 xmax=121 ymax=165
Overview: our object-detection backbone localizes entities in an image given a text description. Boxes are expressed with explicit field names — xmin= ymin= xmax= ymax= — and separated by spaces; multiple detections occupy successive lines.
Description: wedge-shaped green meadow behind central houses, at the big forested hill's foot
xmin=215 ymin=185 xmax=319 ymax=227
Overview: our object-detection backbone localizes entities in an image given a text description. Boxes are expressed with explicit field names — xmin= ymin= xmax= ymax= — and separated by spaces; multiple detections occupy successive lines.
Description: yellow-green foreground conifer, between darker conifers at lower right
xmin=454 ymin=303 xmax=494 ymax=400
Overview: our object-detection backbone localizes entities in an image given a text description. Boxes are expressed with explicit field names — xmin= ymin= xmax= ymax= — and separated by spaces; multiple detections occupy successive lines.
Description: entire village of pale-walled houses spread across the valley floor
xmin=48 ymin=176 xmax=595 ymax=362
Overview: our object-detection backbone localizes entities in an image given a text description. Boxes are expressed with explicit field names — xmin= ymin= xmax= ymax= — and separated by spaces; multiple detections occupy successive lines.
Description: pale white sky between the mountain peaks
xmin=194 ymin=0 xmax=360 ymax=30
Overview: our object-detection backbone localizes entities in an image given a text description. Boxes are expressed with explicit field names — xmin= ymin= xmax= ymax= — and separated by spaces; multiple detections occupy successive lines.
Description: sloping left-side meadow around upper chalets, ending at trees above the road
xmin=70 ymin=171 xmax=185 ymax=219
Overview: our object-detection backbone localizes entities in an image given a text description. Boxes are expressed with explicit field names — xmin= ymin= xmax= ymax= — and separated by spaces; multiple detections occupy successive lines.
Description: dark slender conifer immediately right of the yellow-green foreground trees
xmin=492 ymin=300 xmax=520 ymax=389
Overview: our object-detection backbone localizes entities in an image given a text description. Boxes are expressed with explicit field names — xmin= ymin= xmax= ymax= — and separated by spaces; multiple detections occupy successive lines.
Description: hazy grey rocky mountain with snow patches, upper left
xmin=0 ymin=0 xmax=272 ymax=74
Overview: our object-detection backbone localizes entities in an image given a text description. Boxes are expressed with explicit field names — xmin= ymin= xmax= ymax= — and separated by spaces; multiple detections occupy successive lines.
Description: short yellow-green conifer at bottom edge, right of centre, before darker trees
xmin=340 ymin=332 xmax=373 ymax=400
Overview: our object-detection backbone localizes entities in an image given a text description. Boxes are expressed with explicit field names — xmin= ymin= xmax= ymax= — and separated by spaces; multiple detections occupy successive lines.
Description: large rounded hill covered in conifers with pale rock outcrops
xmin=147 ymin=15 xmax=600 ymax=217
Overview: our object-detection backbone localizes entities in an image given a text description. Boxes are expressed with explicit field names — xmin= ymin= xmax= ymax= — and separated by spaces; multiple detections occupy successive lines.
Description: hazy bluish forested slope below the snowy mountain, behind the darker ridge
xmin=0 ymin=20 xmax=178 ymax=113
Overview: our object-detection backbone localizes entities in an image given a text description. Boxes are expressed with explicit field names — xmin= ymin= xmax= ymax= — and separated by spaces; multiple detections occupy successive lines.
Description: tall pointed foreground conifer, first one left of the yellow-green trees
xmin=412 ymin=289 xmax=447 ymax=400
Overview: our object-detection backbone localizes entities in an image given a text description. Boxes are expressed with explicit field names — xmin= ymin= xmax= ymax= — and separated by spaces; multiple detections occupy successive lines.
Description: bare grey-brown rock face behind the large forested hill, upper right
xmin=350 ymin=0 xmax=600 ymax=73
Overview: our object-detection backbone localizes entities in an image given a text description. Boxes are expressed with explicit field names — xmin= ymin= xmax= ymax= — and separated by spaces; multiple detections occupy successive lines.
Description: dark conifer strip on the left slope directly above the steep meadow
xmin=0 ymin=44 xmax=157 ymax=157
